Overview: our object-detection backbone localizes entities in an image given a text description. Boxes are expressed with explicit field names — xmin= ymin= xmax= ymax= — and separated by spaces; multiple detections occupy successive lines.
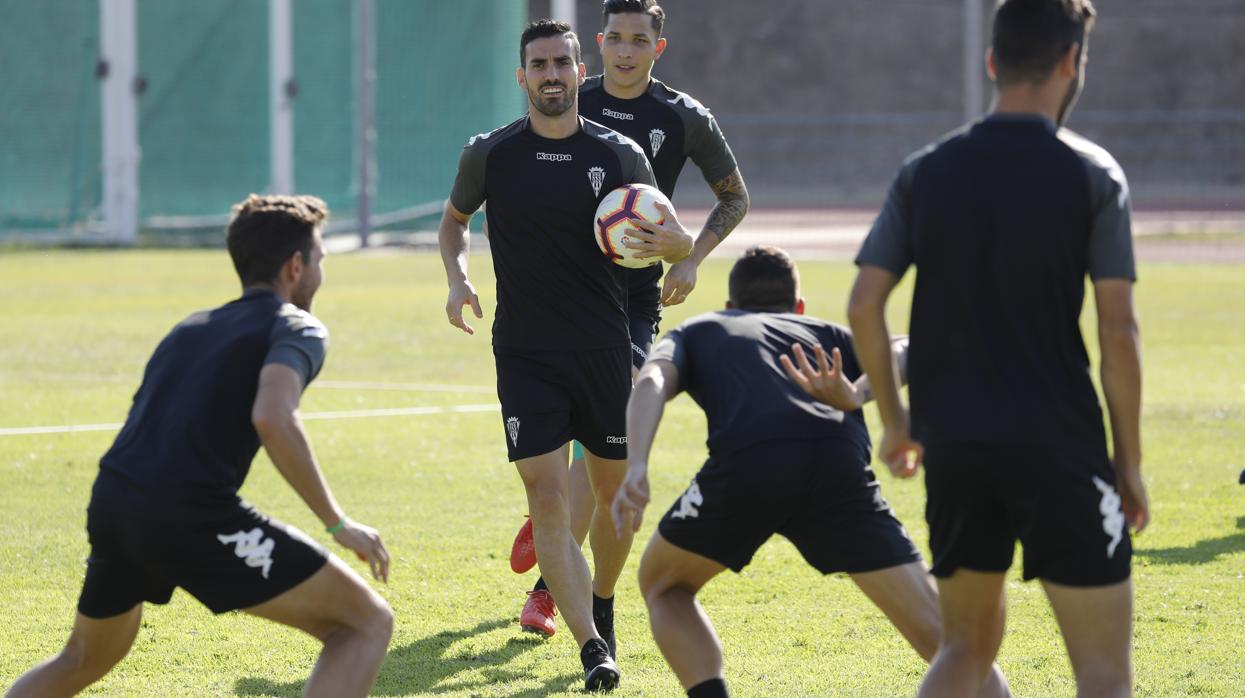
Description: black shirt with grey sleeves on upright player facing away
xmin=857 ymin=114 xmax=1135 ymax=450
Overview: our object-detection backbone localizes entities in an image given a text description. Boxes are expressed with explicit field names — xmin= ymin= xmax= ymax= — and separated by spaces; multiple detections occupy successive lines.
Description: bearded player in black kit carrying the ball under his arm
xmin=439 ymin=20 xmax=687 ymax=689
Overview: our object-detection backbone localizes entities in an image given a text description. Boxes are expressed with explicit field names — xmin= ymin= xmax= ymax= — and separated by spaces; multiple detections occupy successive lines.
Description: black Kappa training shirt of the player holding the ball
xmin=449 ymin=117 xmax=654 ymax=350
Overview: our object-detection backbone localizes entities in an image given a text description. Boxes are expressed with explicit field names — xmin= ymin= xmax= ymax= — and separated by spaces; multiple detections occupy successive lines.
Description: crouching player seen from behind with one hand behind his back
xmin=613 ymin=248 xmax=1008 ymax=698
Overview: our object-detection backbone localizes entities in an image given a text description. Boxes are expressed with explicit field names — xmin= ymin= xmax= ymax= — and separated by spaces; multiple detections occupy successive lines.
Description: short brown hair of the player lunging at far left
xmin=225 ymin=194 xmax=329 ymax=286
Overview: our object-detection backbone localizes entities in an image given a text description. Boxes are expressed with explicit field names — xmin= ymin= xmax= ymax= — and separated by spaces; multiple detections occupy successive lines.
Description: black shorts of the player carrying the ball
xmin=493 ymin=347 xmax=631 ymax=462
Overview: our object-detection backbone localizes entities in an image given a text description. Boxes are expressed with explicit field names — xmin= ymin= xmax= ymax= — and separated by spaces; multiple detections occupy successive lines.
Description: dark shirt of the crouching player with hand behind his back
xmin=649 ymin=310 xmax=869 ymax=460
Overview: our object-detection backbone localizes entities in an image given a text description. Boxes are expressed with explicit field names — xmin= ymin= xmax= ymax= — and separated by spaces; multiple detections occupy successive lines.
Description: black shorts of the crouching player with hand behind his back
xmin=657 ymin=439 xmax=921 ymax=574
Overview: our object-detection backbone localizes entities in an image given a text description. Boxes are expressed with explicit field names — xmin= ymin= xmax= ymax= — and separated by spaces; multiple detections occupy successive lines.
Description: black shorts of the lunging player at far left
xmin=78 ymin=504 xmax=327 ymax=618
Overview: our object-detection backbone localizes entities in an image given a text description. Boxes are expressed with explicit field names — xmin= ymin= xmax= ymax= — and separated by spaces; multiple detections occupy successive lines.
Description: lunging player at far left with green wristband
xmin=9 ymin=194 xmax=393 ymax=697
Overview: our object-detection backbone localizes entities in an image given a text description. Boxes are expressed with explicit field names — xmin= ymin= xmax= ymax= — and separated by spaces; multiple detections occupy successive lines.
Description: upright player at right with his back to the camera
xmin=848 ymin=0 xmax=1148 ymax=696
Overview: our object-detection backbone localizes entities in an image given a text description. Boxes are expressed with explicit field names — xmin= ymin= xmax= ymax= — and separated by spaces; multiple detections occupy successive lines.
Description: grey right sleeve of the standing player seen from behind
xmin=1086 ymin=159 xmax=1137 ymax=281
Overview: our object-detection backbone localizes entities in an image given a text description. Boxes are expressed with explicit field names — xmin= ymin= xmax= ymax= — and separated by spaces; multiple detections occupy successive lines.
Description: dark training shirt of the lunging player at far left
xmin=91 ymin=289 xmax=329 ymax=514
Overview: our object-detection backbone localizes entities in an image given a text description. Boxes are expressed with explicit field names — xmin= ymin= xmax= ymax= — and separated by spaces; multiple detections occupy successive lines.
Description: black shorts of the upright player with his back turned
xmin=925 ymin=445 xmax=1133 ymax=586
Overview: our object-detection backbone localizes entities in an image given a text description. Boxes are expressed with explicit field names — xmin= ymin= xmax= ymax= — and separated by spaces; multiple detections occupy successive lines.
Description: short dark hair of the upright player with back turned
xmin=991 ymin=0 xmax=1096 ymax=86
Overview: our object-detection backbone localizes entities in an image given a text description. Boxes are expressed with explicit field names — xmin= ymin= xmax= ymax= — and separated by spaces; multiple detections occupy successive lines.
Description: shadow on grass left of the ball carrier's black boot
xmin=234 ymin=618 xmax=581 ymax=698
